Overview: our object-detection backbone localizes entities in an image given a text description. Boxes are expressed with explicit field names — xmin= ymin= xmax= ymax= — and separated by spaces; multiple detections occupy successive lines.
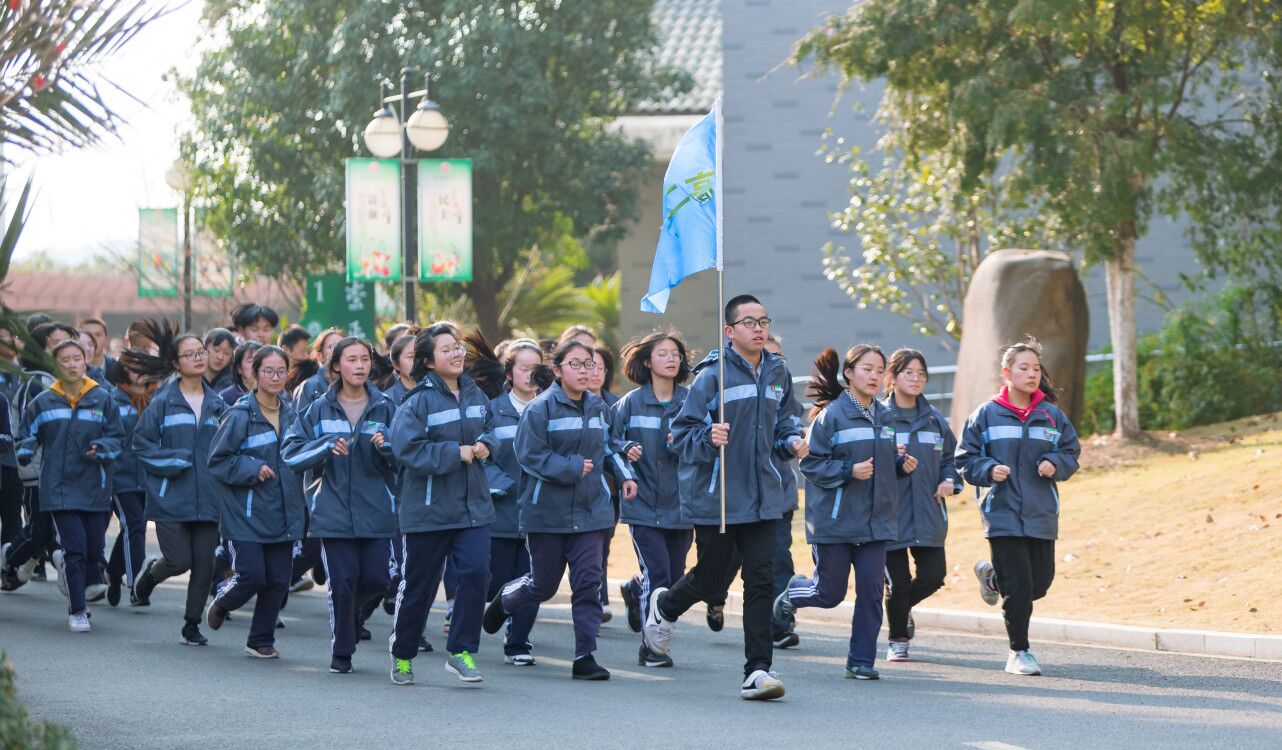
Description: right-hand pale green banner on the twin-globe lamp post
xmin=418 ymin=159 xmax=472 ymax=282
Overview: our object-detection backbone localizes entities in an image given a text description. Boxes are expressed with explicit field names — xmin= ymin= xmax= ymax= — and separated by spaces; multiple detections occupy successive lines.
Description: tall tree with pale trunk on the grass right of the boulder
xmin=795 ymin=0 xmax=1282 ymax=437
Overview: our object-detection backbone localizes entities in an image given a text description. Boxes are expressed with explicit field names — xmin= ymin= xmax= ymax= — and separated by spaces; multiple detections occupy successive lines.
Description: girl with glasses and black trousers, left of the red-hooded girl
xmin=882 ymin=349 xmax=962 ymax=662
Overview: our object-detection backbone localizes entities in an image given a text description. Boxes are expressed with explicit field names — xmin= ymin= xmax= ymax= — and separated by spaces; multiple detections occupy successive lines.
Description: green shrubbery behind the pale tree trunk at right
xmin=1081 ymin=286 xmax=1282 ymax=433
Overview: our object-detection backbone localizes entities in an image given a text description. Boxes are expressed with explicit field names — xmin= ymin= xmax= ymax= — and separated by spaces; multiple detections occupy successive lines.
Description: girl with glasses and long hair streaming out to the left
xmin=121 ymin=321 xmax=228 ymax=646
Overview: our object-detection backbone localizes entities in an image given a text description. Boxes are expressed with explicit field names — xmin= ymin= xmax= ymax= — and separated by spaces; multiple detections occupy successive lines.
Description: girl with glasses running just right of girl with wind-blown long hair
xmin=206 ymin=346 xmax=305 ymax=659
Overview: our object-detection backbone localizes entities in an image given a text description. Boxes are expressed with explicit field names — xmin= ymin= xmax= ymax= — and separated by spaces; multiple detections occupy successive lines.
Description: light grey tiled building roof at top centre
xmin=637 ymin=0 xmax=722 ymax=114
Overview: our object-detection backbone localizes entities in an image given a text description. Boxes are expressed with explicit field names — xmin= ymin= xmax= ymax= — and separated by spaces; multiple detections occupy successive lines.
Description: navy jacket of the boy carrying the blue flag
xmin=672 ymin=344 xmax=801 ymax=526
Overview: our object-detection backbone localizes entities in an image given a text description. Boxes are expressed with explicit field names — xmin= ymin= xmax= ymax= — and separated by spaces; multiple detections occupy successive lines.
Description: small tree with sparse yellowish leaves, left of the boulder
xmin=820 ymin=95 xmax=1064 ymax=351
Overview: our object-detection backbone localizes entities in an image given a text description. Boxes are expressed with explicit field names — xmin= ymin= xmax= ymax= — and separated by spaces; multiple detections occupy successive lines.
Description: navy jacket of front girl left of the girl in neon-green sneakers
xmin=281 ymin=382 xmax=396 ymax=538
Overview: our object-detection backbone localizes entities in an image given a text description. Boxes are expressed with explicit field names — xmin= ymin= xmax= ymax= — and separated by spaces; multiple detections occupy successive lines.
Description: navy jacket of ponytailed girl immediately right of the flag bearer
xmin=801 ymin=391 xmax=899 ymax=545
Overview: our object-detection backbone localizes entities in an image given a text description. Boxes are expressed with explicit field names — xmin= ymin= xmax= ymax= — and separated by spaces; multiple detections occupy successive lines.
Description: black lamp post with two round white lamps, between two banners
xmin=364 ymin=68 xmax=450 ymax=323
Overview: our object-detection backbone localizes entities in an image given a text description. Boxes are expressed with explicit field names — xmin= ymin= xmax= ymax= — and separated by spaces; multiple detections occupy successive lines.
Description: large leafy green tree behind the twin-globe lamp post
xmin=181 ymin=0 xmax=690 ymax=337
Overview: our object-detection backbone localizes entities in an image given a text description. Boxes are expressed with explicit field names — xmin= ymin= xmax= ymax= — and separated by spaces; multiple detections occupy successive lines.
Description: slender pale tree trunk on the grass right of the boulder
xmin=1104 ymin=230 xmax=1140 ymax=438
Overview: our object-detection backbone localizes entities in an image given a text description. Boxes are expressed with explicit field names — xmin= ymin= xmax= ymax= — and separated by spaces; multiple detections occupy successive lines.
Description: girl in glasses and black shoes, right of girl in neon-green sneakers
xmin=485 ymin=338 xmax=637 ymax=679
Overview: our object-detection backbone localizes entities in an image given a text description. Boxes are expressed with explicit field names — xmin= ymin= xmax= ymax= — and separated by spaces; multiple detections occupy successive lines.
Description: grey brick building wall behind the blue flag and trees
xmin=620 ymin=0 xmax=1197 ymax=374
